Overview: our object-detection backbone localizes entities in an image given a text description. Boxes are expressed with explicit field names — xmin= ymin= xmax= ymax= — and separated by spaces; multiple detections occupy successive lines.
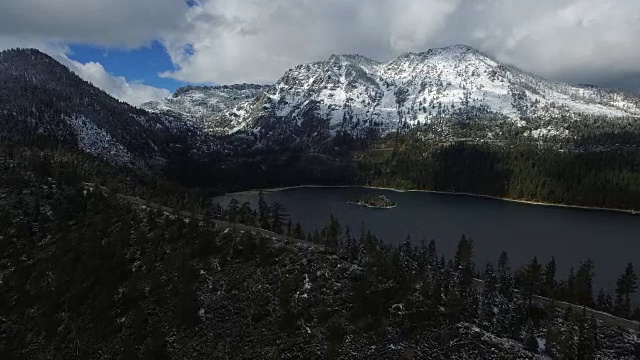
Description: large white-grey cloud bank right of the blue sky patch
xmin=162 ymin=0 xmax=640 ymax=90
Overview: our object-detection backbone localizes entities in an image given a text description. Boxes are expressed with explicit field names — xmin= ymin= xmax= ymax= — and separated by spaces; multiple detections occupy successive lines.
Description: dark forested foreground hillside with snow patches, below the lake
xmin=0 ymin=142 xmax=636 ymax=359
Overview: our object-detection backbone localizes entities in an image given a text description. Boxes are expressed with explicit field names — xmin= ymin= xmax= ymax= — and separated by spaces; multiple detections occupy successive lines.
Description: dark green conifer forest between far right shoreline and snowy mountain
xmin=356 ymin=134 xmax=640 ymax=209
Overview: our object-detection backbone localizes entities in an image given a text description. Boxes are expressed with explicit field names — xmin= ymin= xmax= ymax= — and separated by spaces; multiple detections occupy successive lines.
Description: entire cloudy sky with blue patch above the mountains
xmin=0 ymin=0 xmax=640 ymax=105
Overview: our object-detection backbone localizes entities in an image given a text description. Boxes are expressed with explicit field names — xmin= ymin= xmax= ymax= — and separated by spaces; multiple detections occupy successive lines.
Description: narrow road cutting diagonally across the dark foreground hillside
xmin=83 ymin=183 xmax=640 ymax=331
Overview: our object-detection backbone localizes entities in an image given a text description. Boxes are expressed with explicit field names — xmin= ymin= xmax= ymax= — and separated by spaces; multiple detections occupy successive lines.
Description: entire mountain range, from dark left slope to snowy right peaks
xmin=5 ymin=45 xmax=640 ymax=164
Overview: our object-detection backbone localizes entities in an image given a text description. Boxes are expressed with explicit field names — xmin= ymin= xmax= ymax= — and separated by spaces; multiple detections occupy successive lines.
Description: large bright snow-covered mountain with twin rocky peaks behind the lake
xmin=228 ymin=45 xmax=640 ymax=133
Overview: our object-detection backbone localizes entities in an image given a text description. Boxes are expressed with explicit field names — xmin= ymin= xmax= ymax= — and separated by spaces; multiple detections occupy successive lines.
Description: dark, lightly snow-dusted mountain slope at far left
xmin=0 ymin=49 xmax=215 ymax=168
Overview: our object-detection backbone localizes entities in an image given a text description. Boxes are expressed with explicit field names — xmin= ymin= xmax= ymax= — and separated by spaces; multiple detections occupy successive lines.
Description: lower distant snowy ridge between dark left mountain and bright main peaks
xmin=141 ymin=84 xmax=271 ymax=133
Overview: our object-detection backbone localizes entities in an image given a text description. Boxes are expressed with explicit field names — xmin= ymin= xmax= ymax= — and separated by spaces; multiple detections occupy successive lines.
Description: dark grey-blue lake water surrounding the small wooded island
xmin=215 ymin=187 xmax=640 ymax=289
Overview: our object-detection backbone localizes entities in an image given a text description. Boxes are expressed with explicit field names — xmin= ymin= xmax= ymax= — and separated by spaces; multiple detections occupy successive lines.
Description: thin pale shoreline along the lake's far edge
xmin=217 ymin=185 xmax=640 ymax=215
